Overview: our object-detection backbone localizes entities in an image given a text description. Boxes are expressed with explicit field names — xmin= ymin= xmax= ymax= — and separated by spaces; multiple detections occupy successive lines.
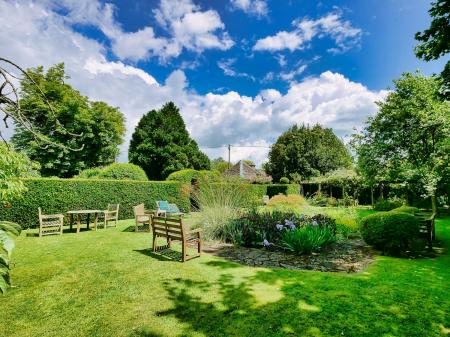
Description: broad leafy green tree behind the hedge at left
xmin=12 ymin=63 xmax=125 ymax=177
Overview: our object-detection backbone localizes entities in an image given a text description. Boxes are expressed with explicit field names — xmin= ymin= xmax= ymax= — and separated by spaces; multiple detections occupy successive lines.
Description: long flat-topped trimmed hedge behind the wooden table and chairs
xmin=0 ymin=178 xmax=190 ymax=228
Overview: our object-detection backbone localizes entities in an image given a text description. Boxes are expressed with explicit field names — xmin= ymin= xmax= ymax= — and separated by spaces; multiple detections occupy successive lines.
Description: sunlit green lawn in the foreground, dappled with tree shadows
xmin=0 ymin=218 xmax=450 ymax=337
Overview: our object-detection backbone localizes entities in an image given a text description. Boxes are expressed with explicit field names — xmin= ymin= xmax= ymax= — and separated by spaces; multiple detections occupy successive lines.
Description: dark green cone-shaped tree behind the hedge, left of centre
xmin=128 ymin=102 xmax=210 ymax=180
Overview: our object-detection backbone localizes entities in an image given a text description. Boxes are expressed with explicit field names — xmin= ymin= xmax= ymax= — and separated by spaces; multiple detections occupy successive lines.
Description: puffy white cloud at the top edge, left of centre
xmin=48 ymin=0 xmax=234 ymax=62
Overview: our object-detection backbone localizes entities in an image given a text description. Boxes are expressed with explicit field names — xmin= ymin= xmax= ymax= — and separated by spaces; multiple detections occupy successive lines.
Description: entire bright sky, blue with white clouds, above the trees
xmin=0 ymin=0 xmax=444 ymax=163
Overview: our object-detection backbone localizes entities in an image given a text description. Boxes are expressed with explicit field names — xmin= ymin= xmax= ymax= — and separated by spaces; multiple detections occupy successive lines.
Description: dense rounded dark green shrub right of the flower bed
xmin=360 ymin=212 xmax=419 ymax=255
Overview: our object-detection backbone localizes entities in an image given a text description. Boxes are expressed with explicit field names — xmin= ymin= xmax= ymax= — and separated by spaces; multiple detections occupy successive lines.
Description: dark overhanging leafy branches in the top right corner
xmin=415 ymin=0 xmax=450 ymax=99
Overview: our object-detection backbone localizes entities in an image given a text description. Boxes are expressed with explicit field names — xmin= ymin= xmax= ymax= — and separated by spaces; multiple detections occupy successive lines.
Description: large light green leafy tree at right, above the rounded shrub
xmin=355 ymin=73 xmax=450 ymax=209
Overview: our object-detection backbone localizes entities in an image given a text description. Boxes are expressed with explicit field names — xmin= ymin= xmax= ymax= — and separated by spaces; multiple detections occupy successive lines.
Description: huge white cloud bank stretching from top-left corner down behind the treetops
xmin=0 ymin=0 xmax=385 ymax=164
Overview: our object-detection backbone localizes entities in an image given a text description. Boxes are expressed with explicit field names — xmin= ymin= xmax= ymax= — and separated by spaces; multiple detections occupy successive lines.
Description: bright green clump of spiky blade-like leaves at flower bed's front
xmin=281 ymin=226 xmax=336 ymax=254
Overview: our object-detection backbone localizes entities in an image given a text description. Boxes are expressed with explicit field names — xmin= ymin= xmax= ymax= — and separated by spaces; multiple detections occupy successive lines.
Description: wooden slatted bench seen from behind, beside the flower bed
xmin=152 ymin=216 xmax=202 ymax=262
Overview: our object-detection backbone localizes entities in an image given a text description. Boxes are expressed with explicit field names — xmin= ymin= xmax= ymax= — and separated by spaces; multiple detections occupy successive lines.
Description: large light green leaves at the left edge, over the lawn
xmin=0 ymin=220 xmax=22 ymax=293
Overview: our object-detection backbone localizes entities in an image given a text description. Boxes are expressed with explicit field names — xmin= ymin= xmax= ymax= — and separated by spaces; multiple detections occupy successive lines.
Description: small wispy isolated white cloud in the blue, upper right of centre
xmin=253 ymin=10 xmax=362 ymax=53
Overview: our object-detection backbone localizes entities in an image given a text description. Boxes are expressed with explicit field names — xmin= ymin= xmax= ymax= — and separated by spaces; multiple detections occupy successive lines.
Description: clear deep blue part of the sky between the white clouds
xmin=74 ymin=0 xmax=444 ymax=95
